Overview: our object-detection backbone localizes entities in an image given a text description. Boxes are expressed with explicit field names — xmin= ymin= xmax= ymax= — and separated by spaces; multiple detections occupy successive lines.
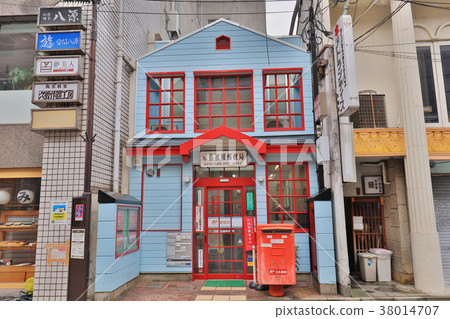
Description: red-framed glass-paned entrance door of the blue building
xmin=205 ymin=187 xmax=247 ymax=279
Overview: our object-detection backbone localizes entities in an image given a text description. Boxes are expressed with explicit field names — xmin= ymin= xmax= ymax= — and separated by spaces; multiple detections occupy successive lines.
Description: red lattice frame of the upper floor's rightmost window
xmin=263 ymin=68 xmax=305 ymax=131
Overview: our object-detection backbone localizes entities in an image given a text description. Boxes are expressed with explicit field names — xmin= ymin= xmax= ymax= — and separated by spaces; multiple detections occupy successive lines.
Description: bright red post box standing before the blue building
xmin=256 ymin=224 xmax=297 ymax=296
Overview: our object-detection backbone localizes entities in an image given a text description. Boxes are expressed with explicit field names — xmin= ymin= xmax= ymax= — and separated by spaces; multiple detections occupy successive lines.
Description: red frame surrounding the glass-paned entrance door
xmin=192 ymin=177 xmax=257 ymax=280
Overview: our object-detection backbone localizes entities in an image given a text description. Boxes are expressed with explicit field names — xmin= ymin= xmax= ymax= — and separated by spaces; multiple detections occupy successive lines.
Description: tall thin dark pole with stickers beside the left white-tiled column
xmin=67 ymin=0 xmax=100 ymax=301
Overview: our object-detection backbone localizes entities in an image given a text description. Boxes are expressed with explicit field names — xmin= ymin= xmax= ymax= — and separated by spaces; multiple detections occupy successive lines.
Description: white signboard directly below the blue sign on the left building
xmin=34 ymin=55 xmax=84 ymax=78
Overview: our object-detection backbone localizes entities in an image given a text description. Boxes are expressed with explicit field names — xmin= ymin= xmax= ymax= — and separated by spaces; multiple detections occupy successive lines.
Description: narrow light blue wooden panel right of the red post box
xmin=314 ymin=201 xmax=336 ymax=284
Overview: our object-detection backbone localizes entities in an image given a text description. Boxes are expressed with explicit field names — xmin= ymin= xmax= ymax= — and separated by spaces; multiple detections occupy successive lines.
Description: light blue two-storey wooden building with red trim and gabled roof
xmin=95 ymin=19 xmax=336 ymax=292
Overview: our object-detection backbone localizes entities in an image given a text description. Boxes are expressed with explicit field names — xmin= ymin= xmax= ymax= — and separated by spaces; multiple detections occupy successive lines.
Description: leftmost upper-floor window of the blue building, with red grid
xmin=146 ymin=74 xmax=184 ymax=133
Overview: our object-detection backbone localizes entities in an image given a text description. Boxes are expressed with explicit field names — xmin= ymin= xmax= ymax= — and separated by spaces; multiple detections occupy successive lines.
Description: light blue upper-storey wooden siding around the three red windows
xmin=136 ymin=21 xmax=314 ymax=137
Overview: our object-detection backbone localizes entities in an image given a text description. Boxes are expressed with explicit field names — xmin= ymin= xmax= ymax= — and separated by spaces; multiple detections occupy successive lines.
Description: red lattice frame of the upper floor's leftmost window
xmin=145 ymin=72 xmax=186 ymax=134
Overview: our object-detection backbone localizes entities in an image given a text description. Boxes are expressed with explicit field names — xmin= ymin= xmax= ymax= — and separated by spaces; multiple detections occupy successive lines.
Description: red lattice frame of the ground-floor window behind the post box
xmin=266 ymin=163 xmax=310 ymax=233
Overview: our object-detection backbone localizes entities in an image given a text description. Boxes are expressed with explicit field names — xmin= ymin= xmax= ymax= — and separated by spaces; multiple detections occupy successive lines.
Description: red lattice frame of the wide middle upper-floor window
xmin=194 ymin=70 xmax=255 ymax=133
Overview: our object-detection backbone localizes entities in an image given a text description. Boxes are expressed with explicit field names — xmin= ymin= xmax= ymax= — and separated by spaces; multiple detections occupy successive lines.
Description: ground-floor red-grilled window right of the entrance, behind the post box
xmin=266 ymin=163 xmax=309 ymax=232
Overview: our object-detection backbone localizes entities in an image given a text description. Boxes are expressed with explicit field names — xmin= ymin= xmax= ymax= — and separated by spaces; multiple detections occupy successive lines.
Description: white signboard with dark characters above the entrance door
xmin=200 ymin=151 xmax=248 ymax=167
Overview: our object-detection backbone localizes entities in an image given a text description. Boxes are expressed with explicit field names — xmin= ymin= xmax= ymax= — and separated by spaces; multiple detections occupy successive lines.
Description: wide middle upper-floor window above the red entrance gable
xmin=195 ymin=73 xmax=253 ymax=132
